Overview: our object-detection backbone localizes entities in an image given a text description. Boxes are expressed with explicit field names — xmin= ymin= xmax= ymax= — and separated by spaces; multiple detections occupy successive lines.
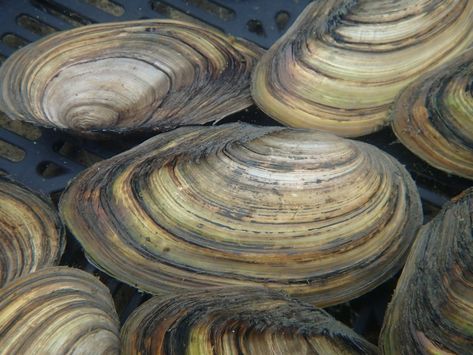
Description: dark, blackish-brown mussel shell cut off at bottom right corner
xmin=380 ymin=188 xmax=473 ymax=355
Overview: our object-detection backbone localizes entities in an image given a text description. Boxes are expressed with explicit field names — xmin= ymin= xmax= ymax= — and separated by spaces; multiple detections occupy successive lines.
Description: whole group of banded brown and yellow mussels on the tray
xmin=0 ymin=0 xmax=473 ymax=354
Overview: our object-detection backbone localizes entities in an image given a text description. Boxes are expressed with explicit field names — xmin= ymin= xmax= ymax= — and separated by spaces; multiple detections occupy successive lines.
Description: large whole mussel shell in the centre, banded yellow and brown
xmin=60 ymin=124 xmax=422 ymax=305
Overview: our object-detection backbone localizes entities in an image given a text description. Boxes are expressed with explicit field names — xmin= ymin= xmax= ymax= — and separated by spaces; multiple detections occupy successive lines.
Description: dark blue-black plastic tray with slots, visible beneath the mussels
xmin=0 ymin=0 xmax=471 ymax=343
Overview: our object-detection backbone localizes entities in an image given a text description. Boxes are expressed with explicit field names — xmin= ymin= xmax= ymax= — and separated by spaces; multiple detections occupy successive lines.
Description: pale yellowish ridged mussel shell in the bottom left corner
xmin=0 ymin=267 xmax=120 ymax=355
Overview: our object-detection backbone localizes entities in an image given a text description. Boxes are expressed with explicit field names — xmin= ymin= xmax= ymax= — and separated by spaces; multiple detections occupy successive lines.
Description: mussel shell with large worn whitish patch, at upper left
xmin=0 ymin=20 xmax=261 ymax=133
